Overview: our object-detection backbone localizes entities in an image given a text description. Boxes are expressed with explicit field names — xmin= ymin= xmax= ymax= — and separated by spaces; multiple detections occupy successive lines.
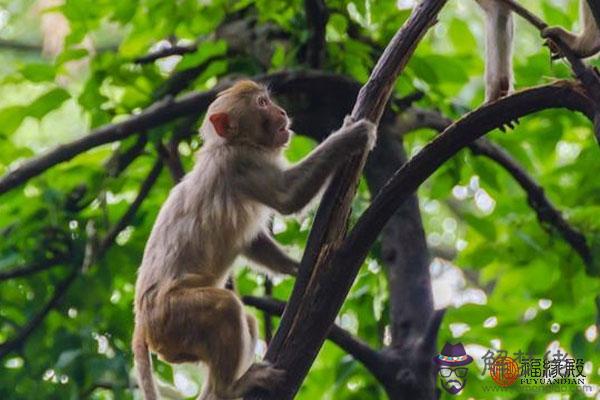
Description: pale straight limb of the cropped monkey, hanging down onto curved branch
xmin=477 ymin=0 xmax=514 ymax=102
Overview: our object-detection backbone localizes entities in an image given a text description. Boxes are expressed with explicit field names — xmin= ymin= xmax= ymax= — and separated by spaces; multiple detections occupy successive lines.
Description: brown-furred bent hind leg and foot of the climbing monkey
xmin=165 ymin=287 xmax=283 ymax=400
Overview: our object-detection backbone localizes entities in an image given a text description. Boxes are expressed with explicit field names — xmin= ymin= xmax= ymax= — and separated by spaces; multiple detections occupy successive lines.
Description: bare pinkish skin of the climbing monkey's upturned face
xmin=255 ymin=93 xmax=290 ymax=148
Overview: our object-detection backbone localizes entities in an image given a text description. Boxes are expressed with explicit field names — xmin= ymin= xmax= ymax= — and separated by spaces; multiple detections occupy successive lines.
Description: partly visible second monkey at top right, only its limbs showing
xmin=476 ymin=0 xmax=600 ymax=102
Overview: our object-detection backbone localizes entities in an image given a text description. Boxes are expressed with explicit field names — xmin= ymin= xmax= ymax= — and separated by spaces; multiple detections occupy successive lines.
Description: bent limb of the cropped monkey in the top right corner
xmin=542 ymin=0 xmax=600 ymax=58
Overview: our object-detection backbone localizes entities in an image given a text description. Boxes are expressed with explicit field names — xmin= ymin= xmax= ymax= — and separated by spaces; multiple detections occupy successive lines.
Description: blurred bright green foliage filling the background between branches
xmin=0 ymin=0 xmax=600 ymax=399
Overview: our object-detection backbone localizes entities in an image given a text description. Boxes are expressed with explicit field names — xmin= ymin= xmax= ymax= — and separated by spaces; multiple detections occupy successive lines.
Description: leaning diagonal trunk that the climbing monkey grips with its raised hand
xmin=259 ymin=0 xmax=446 ymax=399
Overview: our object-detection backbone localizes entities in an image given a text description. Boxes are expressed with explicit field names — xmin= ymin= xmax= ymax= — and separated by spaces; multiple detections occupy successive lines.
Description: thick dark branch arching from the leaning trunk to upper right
xmin=342 ymin=81 xmax=594 ymax=278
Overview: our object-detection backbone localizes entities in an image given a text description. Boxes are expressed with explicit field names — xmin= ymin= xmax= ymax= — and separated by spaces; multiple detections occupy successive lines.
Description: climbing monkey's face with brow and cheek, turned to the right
xmin=240 ymin=92 xmax=290 ymax=149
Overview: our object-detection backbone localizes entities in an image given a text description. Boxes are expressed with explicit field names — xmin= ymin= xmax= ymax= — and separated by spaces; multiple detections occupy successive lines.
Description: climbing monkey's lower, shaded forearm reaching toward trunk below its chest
xmin=243 ymin=232 xmax=299 ymax=276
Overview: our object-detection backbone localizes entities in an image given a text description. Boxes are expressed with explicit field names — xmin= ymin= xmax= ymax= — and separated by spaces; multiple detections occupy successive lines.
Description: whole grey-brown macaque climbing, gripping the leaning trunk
xmin=132 ymin=81 xmax=376 ymax=400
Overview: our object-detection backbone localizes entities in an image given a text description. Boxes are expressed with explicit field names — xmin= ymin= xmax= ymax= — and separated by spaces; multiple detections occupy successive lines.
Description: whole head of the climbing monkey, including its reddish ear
xmin=201 ymin=80 xmax=290 ymax=149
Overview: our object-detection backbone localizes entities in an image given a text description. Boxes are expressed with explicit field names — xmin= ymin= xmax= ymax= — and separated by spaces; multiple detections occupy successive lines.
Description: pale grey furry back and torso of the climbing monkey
xmin=136 ymin=146 xmax=270 ymax=306
